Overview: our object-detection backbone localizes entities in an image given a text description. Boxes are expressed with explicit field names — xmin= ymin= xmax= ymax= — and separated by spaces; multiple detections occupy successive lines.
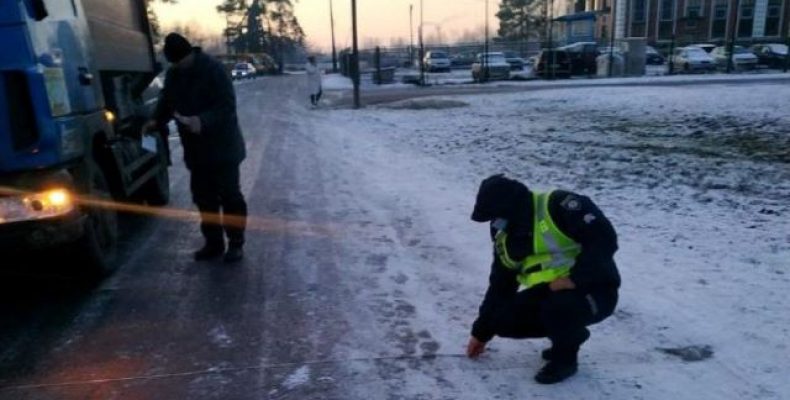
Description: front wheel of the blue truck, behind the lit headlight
xmin=75 ymin=168 xmax=118 ymax=279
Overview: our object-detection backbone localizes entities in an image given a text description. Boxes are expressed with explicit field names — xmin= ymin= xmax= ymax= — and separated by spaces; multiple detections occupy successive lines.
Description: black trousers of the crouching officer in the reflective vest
xmin=491 ymin=285 xmax=617 ymax=363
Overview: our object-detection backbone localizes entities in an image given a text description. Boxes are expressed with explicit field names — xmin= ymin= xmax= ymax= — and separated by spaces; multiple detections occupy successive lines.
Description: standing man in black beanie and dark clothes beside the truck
xmin=143 ymin=33 xmax=247 ymax=263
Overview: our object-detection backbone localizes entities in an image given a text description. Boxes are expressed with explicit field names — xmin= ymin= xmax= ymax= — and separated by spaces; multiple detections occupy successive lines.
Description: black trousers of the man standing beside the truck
xmin=190 ymin=163 xmax=247 ymax=247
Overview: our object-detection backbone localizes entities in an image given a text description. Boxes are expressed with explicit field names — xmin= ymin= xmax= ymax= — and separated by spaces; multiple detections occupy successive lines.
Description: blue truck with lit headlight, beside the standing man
xmin=0 ymin=0 xmax=169 ymax=275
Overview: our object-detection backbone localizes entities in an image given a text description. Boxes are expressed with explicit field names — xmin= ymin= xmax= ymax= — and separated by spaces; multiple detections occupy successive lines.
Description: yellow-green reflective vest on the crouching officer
xmin=494 ymin=192 xmax=582 ymax=289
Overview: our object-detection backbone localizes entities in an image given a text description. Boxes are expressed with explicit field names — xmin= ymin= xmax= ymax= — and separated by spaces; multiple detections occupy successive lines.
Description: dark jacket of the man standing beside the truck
xmin=155 ymin=48 xmax=246 ymax=169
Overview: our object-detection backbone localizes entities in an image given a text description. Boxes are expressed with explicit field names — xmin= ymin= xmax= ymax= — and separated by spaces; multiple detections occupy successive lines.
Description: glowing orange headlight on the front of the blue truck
xmin=0 ymin=188 xmax=75 ymax=223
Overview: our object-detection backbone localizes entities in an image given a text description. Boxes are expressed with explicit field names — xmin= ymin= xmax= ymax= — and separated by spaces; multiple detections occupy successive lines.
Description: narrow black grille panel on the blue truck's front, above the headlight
xmin=2 ymin=71 xmax=38 ymax=150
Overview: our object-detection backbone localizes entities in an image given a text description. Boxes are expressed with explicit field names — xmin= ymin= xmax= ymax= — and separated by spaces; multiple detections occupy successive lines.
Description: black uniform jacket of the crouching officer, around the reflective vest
xmin=472 ymin=190 xmax=620 ymax=341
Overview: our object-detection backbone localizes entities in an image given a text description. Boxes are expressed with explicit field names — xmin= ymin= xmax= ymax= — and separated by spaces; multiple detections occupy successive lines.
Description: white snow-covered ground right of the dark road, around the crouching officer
xmin=302 ymin=84 xmax=790 ymax=400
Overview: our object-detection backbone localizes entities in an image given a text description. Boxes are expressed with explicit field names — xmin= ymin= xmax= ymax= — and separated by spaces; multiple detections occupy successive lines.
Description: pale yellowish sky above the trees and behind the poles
xmin=155 ymin=0 xmax=499 ymax=49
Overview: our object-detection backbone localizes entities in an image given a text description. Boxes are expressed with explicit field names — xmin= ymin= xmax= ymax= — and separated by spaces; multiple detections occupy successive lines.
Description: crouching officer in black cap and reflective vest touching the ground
xmin=467 ymin=175 xmax=620 ymax=384
